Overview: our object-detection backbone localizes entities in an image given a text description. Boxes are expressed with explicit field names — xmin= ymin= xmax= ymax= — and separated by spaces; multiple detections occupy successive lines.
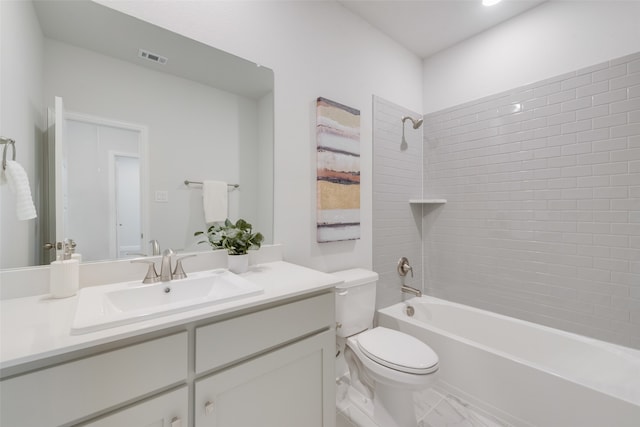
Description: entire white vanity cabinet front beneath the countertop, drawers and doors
xmin=0 ymin=289 xmax=335 ymax=427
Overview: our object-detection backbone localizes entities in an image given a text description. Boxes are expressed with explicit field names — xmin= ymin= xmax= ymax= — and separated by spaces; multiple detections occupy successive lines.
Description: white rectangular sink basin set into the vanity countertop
xmin=71 ymin=269 xmax=263 ymax=335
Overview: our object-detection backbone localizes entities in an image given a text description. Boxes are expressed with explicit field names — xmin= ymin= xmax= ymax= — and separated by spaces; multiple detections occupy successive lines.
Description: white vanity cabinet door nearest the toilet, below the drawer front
xmin=195 ymin=331 xmax=335 ymax=427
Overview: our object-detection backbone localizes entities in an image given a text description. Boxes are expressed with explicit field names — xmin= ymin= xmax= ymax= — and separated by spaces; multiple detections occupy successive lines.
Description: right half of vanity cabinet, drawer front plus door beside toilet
xmin=195 ymin=293 xmax=335 ymax=427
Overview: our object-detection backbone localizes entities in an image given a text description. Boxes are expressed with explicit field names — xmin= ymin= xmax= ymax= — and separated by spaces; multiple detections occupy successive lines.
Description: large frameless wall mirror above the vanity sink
xmin=0 ymin=0 xmax=273 ymax=268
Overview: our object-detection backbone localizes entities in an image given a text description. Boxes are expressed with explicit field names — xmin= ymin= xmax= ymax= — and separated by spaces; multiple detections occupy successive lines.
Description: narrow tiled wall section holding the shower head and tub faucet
xmin=373 ymin=96 xmax=423 ymax=308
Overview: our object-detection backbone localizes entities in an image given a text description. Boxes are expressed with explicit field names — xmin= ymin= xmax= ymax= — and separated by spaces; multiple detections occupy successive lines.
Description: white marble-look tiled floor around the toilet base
xmin=336 ymin=378 xmax=509 ymax=427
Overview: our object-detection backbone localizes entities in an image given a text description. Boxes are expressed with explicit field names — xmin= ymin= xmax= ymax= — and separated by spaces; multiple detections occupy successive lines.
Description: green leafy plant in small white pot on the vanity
xmin=193 ymin=218 xmax=264 ymax=273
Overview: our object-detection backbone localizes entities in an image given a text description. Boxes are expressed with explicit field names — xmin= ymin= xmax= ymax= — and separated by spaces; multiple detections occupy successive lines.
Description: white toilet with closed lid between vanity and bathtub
xmin=332 ymin=268 xmax=438 ymax=427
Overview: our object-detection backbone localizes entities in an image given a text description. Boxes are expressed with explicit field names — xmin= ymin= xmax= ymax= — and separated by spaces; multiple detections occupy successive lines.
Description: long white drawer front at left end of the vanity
xmin=0 ymin=332 xmax=187 ymax=427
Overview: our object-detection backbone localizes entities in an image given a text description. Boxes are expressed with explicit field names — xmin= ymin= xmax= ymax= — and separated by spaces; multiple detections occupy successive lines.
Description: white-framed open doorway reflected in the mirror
xmin=58 ymin=107 xmax=146 ymax=261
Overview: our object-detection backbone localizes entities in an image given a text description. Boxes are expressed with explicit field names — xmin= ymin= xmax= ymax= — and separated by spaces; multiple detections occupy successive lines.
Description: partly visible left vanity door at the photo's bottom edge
xmin=82 ymin=386 xmax=189 ymax=427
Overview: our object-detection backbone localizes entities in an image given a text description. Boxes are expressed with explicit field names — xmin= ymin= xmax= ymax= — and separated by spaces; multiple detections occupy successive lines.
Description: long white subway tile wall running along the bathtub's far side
xmin=422 ymin=53 xmax=640 ymax=348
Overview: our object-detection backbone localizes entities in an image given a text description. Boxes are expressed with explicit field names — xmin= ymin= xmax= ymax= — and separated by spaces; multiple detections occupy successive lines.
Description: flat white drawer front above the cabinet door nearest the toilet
xmin=196 ymin=292 xmax=335 ymax=374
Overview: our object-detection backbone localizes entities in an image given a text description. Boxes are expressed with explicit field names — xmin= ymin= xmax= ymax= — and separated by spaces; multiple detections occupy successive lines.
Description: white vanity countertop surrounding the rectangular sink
xmin=0 ymin=261 xmax=340 ymax=371
